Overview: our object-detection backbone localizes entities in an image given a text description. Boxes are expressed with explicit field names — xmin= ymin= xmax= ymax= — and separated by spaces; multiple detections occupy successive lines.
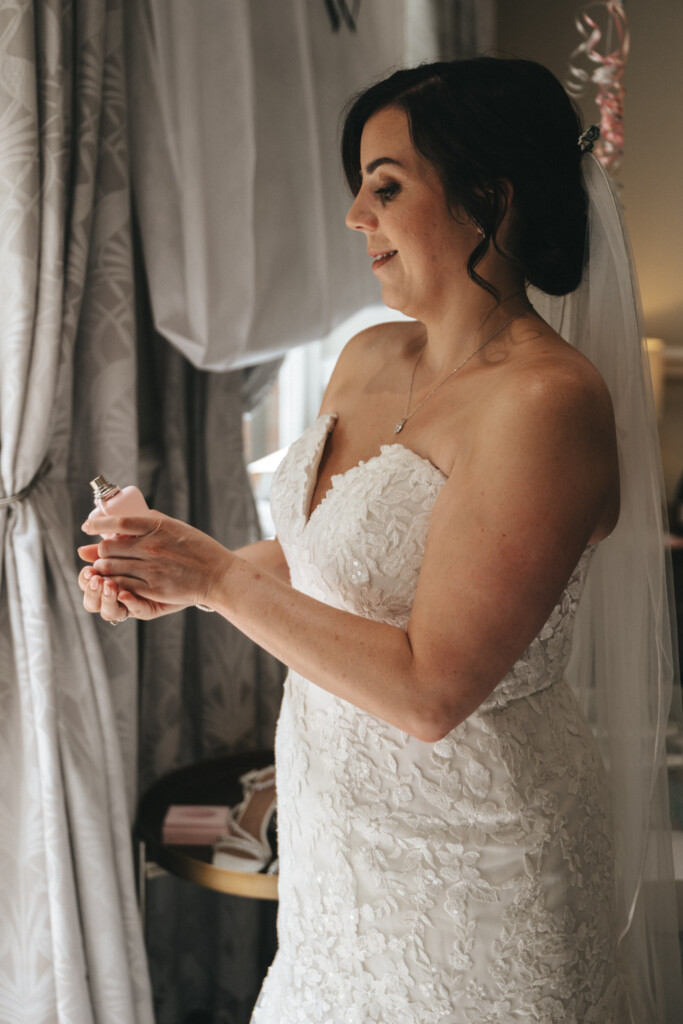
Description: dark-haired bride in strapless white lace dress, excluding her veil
xmin=80 ymin=58 xmax=679 ymax=1024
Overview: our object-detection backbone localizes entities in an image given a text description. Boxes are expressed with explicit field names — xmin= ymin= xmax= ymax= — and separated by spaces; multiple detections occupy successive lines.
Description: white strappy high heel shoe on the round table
xmin=212 ymin=765 xmax=276 ymax=872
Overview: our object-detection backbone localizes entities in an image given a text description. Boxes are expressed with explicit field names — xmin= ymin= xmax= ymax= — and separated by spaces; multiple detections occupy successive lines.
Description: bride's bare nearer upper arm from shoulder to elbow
xmin=408 ymin=364 xmax=615 ymax=731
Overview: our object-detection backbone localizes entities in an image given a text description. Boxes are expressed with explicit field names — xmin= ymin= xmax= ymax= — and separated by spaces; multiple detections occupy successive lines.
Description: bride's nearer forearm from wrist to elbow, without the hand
xmin=209 ymin=557 xmax=440 ymax=738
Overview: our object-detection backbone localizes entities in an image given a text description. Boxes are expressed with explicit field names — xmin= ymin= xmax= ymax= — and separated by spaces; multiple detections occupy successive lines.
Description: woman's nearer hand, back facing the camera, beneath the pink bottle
xmin=79 ymin=512 xmax=233 ymax=607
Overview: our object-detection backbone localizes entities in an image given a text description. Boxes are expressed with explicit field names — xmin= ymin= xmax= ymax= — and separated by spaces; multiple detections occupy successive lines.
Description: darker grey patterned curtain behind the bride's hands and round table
xmin=139 ymin=329 xmax=284 ymax=1024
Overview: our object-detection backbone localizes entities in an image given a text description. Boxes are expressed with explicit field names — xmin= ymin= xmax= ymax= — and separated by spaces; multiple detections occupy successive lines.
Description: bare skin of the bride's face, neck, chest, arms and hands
xmin=79 ymin=108 xmax=618 ymax=742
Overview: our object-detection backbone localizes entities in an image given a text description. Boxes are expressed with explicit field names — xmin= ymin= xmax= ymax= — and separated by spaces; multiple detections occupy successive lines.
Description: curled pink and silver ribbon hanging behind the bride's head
xmin=566 ymin=0 xmax=630 ymax=174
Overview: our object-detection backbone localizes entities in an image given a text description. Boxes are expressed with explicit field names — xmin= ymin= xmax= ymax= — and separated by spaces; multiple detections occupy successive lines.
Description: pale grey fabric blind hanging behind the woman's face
xmin=129 ymin=0 xmax=411 ymax=371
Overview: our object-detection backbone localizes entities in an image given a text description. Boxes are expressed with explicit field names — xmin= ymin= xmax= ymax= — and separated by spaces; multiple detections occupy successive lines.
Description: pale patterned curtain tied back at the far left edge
xmin=0 ymin=0 xmax=152 ymax=1024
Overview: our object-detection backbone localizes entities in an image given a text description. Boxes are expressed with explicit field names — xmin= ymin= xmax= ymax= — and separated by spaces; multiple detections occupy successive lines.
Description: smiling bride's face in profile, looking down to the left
xmin=346 ymin=106 xmax=480 ymax=322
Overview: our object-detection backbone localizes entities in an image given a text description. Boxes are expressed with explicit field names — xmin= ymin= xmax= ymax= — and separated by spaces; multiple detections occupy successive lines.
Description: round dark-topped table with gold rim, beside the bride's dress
xmin=135 ymin=751 xmax=278 ymax=921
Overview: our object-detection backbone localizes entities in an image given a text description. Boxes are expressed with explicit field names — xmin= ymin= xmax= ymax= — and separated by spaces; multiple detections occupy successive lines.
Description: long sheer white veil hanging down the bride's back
xmin=530 ymin=154 xmax=683 ymax=1024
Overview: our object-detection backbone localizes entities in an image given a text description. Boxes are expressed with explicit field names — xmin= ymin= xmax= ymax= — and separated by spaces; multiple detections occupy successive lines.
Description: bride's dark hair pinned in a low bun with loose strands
xmin=342 ymin=57 xmax=587 ymax=299
